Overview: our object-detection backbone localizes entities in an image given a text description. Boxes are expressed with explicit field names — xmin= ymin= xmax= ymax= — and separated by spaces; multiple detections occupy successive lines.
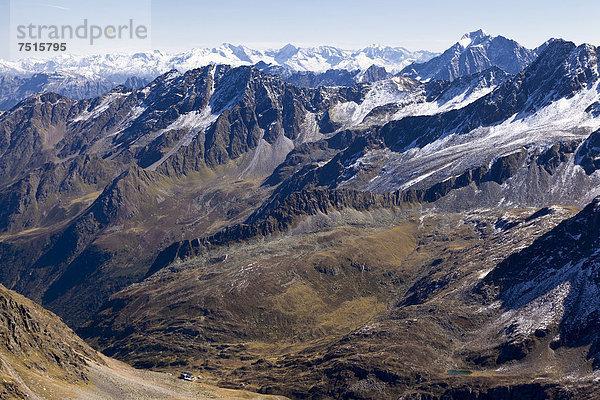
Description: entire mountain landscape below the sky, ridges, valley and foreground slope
xmin=0 ymin=30 xmax=600 ymax=400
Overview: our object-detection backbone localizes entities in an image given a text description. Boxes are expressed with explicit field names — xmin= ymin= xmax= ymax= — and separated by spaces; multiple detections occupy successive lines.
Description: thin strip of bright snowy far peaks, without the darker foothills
xmin=0 ymin=43 xmax=437 ymax=81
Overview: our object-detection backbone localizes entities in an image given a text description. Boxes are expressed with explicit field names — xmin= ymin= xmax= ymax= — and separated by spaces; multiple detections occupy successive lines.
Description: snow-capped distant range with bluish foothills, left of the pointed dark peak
xmin=0 ymin=44 xmax=436 ymax=110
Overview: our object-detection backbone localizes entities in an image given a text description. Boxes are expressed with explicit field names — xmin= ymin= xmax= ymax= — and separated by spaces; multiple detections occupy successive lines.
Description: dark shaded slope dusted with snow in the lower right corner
xmin=477 ymin=198 xmax=600 ymax=367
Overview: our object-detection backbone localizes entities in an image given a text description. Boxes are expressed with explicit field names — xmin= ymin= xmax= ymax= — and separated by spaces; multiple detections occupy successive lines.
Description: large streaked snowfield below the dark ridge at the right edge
xmin=363 ymin=83 xmax=600 ymax=192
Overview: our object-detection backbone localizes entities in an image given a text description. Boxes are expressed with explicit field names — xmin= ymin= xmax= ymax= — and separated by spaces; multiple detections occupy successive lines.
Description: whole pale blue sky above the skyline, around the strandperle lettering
xmin=0 ymin=0 xmax=600 ymax=57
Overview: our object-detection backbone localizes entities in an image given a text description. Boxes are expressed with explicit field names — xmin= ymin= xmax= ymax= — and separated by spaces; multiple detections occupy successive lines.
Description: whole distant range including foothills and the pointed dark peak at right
xmin=0 ymin=30 xmax=547 ymax=110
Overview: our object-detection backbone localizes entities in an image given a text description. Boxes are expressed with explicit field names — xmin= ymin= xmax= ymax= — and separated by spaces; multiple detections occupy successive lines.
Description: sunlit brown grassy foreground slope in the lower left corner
xmin=0 ymin=286 xmax=288 ymax=400
